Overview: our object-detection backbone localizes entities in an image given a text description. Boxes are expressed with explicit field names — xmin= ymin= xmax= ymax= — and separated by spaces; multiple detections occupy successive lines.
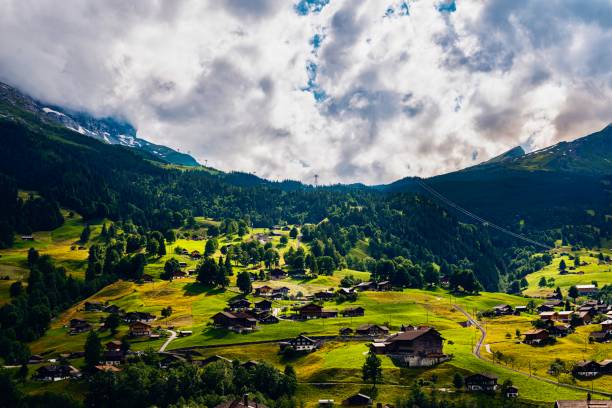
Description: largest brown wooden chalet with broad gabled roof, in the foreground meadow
xmin=370 ymin=326 xmax=449 ymax=367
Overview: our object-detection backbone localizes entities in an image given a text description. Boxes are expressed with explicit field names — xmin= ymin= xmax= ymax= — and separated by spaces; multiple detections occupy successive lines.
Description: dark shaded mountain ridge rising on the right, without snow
xmin=377 ymin=125 xmax=612 ymax=237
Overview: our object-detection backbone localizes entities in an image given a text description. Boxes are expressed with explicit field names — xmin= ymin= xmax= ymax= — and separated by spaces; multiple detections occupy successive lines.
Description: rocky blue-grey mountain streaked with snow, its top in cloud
xmin=0 ymin=82 xmax=199 ymax=166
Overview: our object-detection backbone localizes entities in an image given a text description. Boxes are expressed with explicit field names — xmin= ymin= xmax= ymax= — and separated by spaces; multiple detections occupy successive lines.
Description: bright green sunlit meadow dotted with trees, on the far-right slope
xmin=523 ymin=248 xmax=612 ymax=297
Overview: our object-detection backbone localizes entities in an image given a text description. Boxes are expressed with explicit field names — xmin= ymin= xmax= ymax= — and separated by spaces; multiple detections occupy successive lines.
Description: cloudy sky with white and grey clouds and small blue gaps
xmin=0 ymin=0 xmax=612 ymax=184
